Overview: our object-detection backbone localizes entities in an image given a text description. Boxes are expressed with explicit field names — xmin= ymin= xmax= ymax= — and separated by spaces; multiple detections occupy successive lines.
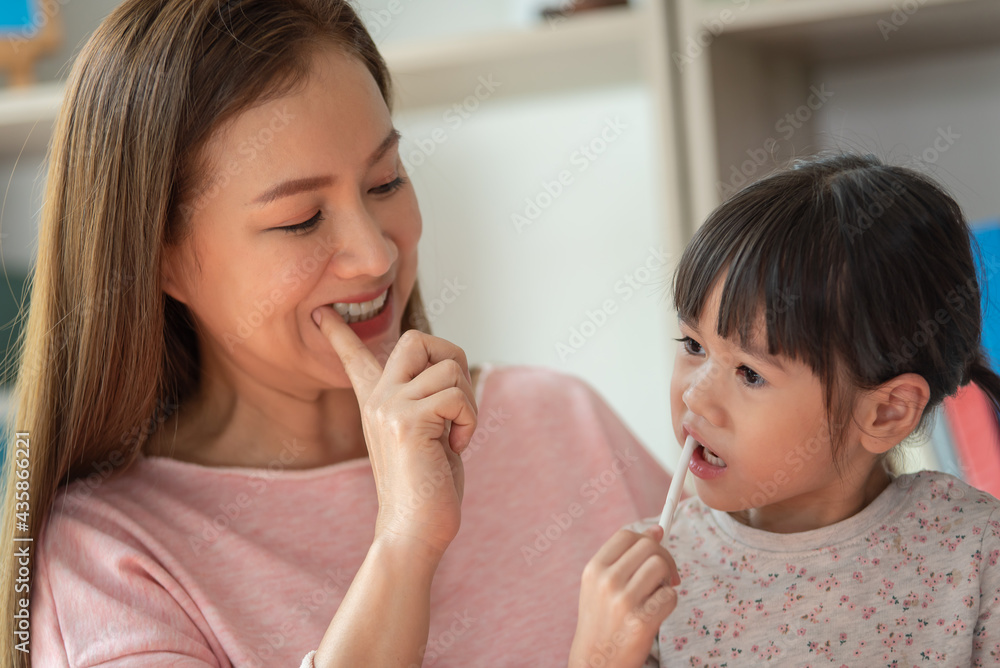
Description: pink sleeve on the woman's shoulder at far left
xmin=30 ymin=504 xmax=231 ymax=668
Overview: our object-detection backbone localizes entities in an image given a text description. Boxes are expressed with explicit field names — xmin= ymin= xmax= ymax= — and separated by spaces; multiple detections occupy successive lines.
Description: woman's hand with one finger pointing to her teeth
xmin=319 ymin=306 xmax=477 ymax=567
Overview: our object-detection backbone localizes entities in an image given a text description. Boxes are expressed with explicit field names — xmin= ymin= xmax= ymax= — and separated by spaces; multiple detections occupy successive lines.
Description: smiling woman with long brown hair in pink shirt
xmin=3 ymin=0 xmax=668 ymax=668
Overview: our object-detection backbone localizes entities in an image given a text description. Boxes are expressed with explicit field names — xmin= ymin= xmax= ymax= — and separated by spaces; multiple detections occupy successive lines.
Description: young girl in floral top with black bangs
xmin=570 ymin=156 xmax=1000 ymax=668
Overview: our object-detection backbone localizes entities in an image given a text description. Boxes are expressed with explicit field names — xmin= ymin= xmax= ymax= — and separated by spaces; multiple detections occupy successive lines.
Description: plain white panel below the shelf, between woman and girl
xmin=397 ymin=87 xmax=676 ymax=462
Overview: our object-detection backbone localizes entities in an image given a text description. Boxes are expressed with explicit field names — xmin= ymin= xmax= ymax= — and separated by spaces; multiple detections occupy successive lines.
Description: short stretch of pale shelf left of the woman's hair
xmin=0 ymin=82 xmax=64 ymax=156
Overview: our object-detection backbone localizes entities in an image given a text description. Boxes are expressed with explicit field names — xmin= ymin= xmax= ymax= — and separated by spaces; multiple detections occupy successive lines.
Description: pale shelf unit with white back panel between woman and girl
xmin=380 ymin=0 xmax=688 ymax=462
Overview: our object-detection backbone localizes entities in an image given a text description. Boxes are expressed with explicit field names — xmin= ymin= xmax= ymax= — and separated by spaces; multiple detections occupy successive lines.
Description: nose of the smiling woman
xmin=330 ymin=202 xmax=399 ymax=279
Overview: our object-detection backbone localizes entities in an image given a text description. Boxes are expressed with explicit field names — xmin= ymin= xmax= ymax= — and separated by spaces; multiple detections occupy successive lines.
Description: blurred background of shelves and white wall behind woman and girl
xmin=0 ymin=0 xmax=1000 ymax=494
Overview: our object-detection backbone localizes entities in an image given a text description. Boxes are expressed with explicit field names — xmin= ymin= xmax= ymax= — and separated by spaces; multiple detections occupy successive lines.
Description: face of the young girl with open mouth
xmin=670 ymin=281 xmax=871 ymax=532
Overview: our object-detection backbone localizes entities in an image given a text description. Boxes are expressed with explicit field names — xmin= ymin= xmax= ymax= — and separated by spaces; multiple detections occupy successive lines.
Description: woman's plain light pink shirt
xmin=30 ymin=366 xmax=669 ymax=668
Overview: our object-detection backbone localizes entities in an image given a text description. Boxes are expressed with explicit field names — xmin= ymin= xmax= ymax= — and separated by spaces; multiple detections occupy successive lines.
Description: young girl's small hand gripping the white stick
xmin=569 ymin=525 xmax=680 ymax=668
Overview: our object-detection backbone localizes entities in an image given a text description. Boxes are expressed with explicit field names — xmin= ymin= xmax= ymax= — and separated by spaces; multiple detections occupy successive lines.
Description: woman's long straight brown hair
xmin=0 ymin=0 xmax=426 ymax=668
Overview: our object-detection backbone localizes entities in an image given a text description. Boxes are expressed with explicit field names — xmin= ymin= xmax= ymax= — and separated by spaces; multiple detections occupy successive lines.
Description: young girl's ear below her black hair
xmin=857 ymin=373 xmax=931 ymax=455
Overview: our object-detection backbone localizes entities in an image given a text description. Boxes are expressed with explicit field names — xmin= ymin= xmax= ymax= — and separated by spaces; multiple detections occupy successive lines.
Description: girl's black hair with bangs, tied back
xmin=674 ymin=155 xmax=1000 ymax=462
